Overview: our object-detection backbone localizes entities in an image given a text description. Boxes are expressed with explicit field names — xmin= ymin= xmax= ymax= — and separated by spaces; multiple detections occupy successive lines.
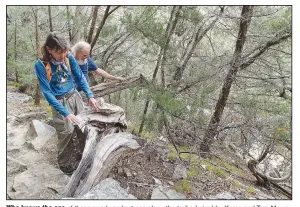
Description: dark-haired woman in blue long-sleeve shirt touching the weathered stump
xmin=35 ymin=33 xmax=99 ymax=174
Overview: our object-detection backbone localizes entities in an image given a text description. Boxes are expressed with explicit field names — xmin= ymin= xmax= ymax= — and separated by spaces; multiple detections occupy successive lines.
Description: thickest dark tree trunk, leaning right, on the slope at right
xmin=199 ymin=6 xmax=253 ymax=156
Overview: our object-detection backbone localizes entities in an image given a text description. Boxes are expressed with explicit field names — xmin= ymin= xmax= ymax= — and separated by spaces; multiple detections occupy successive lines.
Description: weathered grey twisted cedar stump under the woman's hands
xmin=62 ymin=102 xmax=140 ymax=198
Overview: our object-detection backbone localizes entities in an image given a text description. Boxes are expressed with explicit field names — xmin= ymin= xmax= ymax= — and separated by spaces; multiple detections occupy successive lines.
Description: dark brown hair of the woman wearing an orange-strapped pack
xmin=41 ymin=32 xmax=69 ymax=62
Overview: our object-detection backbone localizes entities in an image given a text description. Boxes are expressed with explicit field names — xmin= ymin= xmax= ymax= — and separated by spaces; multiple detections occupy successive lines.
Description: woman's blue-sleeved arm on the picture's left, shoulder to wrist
xmin=34 ymin=61 xmax=70 ymax=117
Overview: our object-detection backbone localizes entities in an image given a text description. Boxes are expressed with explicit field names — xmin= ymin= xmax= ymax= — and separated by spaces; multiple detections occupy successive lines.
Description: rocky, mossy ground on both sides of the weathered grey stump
xmin=7 ymin=87 xmax=287 ymax=200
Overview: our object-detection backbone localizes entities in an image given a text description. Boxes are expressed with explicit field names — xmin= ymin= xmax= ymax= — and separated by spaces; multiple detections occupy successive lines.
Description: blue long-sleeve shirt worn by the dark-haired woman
xmin=34 ymin=55 xmax=94 ymax=117
